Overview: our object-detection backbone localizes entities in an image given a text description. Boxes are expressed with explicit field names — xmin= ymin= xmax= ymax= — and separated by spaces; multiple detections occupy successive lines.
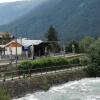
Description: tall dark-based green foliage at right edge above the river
xmin=86 ymin=38 xmax=100 ymax=77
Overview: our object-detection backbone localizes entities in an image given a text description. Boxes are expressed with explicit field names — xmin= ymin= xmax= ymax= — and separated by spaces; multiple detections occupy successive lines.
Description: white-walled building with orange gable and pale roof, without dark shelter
xmin=5 ymin=38 xmax=43 ymax=55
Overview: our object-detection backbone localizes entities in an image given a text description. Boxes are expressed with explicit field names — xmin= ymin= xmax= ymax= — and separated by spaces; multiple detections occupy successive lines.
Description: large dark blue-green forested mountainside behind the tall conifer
xmin=0 ymin=0 xmax=100 ymax=41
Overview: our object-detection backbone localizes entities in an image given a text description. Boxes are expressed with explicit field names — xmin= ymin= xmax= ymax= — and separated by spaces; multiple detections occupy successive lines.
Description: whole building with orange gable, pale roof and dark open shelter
xmin=3 ymin=38 xmax=47 ymax=57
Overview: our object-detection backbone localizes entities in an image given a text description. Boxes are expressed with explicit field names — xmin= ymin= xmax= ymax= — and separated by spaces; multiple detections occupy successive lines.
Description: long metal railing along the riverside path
xmin=0 ymin=65 xmax=86 ymax=82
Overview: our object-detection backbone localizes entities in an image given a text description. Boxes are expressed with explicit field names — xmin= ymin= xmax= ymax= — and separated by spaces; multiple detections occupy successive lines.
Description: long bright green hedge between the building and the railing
xmin=18 ymin=57 xmax=80 ymax=71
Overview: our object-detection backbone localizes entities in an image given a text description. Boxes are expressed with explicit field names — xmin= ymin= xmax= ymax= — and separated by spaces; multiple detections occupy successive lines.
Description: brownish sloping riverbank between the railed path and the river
xmin=0 ymin=69 xmax=88 ymax=98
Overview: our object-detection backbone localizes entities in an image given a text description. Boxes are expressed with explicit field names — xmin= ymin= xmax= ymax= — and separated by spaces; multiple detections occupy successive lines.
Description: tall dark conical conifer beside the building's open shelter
xmin=45 ymin=26 xmax=61 ymax=52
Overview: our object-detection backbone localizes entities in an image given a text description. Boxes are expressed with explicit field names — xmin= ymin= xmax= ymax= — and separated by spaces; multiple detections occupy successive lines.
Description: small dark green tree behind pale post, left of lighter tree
xmin=65 ymin=41 xmax=79 ymax=53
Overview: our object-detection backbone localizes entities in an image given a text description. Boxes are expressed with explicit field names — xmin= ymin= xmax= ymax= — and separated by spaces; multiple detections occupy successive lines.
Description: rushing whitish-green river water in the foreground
xmin=13 ymin=78 xmax=100 ymax=100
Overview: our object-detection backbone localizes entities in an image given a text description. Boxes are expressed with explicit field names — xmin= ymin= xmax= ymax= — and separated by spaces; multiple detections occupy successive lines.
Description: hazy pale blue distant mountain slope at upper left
xmin=0 ymin=0 xmax=45 ymax=25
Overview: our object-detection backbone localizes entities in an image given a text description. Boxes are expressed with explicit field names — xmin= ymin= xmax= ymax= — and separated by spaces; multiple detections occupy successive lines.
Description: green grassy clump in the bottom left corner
xmin=0 ymin=87 xmax=11 ymax=100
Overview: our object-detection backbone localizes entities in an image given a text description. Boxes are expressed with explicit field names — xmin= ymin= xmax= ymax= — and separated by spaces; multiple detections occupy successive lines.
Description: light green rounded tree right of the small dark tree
xmin=79 ymin=36 xmax=94 ymax=52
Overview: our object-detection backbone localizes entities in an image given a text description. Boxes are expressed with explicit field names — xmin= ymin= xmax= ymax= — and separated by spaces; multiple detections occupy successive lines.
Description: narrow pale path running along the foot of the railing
xmin=0 ymin=66 xmax=87 ymax=82
